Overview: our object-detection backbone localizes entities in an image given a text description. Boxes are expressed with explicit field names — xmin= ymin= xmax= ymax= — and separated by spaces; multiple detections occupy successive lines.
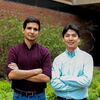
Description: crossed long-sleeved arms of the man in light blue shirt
xmin=51 ymin=55 xmax=93 ymax=92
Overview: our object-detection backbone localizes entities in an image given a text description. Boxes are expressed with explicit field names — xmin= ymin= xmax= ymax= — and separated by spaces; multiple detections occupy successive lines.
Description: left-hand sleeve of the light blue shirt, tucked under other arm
xmin=51 ymin=61 xmax=79 ymax=91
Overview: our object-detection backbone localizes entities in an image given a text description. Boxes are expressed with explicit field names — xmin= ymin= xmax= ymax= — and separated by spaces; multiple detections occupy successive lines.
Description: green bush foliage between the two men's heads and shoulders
xmin=37 ymin=25 xmax=65 ymax=60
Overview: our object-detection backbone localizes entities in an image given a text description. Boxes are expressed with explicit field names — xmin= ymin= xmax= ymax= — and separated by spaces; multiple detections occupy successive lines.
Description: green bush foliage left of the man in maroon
xmin=0 ymin=17 xmax=22 ymax=76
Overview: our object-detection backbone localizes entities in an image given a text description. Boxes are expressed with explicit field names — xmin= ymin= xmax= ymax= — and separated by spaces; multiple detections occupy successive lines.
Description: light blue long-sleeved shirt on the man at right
xmin=51 ymin=48 xmax=93 ymax=100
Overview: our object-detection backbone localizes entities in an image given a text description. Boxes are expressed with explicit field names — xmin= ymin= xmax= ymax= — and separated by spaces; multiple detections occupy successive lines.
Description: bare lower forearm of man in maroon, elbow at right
xmin=25 ymin=74 xmax=50 ymax=82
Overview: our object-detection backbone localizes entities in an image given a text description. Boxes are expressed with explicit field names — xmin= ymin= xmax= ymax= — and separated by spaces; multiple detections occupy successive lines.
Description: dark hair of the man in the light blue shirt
xmin=62 ymin=25 xmax=80 ymax=37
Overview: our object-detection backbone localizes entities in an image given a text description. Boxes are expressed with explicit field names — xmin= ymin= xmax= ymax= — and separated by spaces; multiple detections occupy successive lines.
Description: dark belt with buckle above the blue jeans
xmin=14 ymin=89 xmax=44 ymax=96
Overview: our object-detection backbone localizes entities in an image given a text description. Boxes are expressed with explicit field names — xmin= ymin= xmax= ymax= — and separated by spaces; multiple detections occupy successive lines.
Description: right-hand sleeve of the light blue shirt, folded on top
xmin=60 ymin=56 xmax=93 ymax=88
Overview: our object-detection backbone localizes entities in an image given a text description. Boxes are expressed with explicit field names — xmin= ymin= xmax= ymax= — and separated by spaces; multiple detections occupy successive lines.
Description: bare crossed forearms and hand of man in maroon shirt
xmin=8 ymin=63 xmax=50 ymax=82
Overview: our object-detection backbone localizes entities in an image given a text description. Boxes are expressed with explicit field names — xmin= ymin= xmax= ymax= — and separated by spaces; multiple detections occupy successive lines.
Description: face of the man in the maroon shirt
xmin=23 ymin=22 xmax=39 ymax=41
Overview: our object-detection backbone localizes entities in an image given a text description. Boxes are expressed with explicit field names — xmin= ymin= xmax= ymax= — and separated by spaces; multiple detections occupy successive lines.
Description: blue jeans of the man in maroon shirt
xmin=13 ymin=92 xmax=46 ymax=100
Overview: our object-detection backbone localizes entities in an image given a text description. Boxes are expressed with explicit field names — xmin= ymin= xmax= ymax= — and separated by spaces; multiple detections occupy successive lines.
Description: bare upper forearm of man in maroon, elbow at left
xmin=8 ymin=69 xmax=42 ymax=80
